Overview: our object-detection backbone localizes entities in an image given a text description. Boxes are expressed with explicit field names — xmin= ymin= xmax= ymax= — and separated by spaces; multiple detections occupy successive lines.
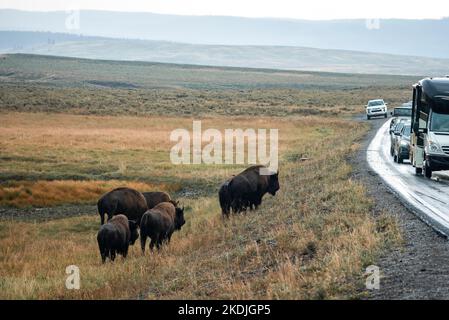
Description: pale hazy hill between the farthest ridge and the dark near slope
xmin=0 ymin=32 xmax=449 ymax=76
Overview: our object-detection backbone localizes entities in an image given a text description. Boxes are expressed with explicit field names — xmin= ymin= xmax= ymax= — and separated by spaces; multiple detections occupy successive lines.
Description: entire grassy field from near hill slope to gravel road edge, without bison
xmin=0 ymin=55 xmax=402 ymax=299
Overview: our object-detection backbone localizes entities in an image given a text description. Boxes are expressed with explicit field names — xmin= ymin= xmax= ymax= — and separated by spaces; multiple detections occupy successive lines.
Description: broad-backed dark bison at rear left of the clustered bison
xmin=97 ymin=188 xmax=148 ymax=225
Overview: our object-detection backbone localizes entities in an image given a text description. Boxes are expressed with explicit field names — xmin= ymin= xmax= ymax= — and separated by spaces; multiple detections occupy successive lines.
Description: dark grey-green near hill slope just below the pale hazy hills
xmin=0 ymin=54 xmax=419 ymax=90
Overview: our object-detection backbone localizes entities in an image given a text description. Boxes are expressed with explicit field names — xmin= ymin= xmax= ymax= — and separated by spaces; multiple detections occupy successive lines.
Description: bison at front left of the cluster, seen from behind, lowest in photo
xmin=97 ymin=214 xmax=139 ymax=263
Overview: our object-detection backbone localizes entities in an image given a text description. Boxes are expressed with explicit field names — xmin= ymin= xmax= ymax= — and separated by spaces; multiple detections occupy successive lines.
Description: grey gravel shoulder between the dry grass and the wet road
xmin=351 ymin=115 xmax=449 ymax=299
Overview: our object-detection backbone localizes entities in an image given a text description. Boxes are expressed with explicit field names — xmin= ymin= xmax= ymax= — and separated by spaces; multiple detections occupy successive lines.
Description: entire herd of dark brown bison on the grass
xmin=97 ymin=166 xmax=279 ymax=263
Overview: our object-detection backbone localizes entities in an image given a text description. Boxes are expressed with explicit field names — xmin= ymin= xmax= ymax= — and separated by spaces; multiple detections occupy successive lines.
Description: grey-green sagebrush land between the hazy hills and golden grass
xmin=0 ymin=55 xmax=419 ymax=117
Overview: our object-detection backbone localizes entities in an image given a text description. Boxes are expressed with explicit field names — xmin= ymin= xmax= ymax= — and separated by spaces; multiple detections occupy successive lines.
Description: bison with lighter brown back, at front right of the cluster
xmin=140 ymin=202 xmax=185 ymax=253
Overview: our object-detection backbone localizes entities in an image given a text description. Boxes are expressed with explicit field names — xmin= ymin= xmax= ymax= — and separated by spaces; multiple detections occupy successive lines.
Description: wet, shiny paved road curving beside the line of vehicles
xmin=367 ymin=121 xmax=449 ymax=236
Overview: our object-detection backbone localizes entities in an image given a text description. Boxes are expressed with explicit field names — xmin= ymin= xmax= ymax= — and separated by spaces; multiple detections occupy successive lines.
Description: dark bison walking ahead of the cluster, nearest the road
xmin=218 ymin=165 xmax=279 ymax=216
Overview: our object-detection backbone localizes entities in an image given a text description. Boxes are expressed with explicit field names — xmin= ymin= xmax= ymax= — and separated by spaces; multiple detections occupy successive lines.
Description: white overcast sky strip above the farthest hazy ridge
xmin=0 ymin=0 xmax=449 ymax=20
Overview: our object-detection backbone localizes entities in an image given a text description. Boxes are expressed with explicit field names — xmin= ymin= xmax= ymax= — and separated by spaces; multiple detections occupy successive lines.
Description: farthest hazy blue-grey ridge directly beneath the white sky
xmin=0 ymin=10 xmax=449 ymax=58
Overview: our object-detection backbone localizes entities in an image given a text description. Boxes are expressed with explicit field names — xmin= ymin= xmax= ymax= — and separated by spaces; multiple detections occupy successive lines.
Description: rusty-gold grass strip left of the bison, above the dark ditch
xmin=0 ymin=180 xmax=180 ymax=208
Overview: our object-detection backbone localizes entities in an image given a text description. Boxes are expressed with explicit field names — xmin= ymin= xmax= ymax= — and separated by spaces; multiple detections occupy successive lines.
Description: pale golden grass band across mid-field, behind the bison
xmin=0 ymin=113 xmax=344 ymax=191
